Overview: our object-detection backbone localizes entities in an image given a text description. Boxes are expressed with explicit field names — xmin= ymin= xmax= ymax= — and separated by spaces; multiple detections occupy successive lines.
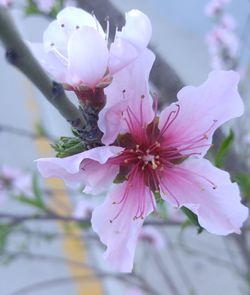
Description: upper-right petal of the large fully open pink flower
xmin=159 ymin=71 xmax=243 ymax=155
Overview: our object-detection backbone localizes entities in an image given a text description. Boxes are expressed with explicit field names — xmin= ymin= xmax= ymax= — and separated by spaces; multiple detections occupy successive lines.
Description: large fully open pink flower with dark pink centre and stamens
xmin=38 ymin=67 xmax=248 ymax=272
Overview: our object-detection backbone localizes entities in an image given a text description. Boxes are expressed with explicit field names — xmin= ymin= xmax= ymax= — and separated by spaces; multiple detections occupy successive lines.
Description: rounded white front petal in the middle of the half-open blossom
xmin=68 ymin=27 xmax=109 ymax=87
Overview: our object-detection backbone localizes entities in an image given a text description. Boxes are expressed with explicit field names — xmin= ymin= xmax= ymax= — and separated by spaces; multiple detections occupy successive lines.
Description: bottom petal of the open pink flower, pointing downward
xmin=91 ymin=182 xmax=151 ymax=272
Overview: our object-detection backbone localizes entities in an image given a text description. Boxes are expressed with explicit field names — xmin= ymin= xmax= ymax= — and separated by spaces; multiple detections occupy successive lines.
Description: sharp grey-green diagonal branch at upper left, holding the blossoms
xmin=0 ymin=5 xmax=86 ymax=129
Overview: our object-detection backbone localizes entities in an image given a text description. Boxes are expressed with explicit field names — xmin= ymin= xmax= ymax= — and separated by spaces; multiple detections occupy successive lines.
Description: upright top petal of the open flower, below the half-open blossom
xmin=98 ymin=49 xmax=155 ymax=144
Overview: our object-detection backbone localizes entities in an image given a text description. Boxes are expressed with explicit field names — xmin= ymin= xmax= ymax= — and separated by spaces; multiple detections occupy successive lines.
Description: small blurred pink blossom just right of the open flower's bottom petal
xmin=139 ymin=225 xmax=165 ymax=251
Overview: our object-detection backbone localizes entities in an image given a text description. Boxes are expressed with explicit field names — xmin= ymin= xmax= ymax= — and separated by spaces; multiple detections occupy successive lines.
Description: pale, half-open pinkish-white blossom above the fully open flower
xmin=30 ymin=7 xmax=152 ymax=91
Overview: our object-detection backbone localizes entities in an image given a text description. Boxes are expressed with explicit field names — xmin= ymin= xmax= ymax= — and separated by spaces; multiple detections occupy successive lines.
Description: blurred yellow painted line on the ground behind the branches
xmin=22 ymin=81 xmax=103 ymax=295
